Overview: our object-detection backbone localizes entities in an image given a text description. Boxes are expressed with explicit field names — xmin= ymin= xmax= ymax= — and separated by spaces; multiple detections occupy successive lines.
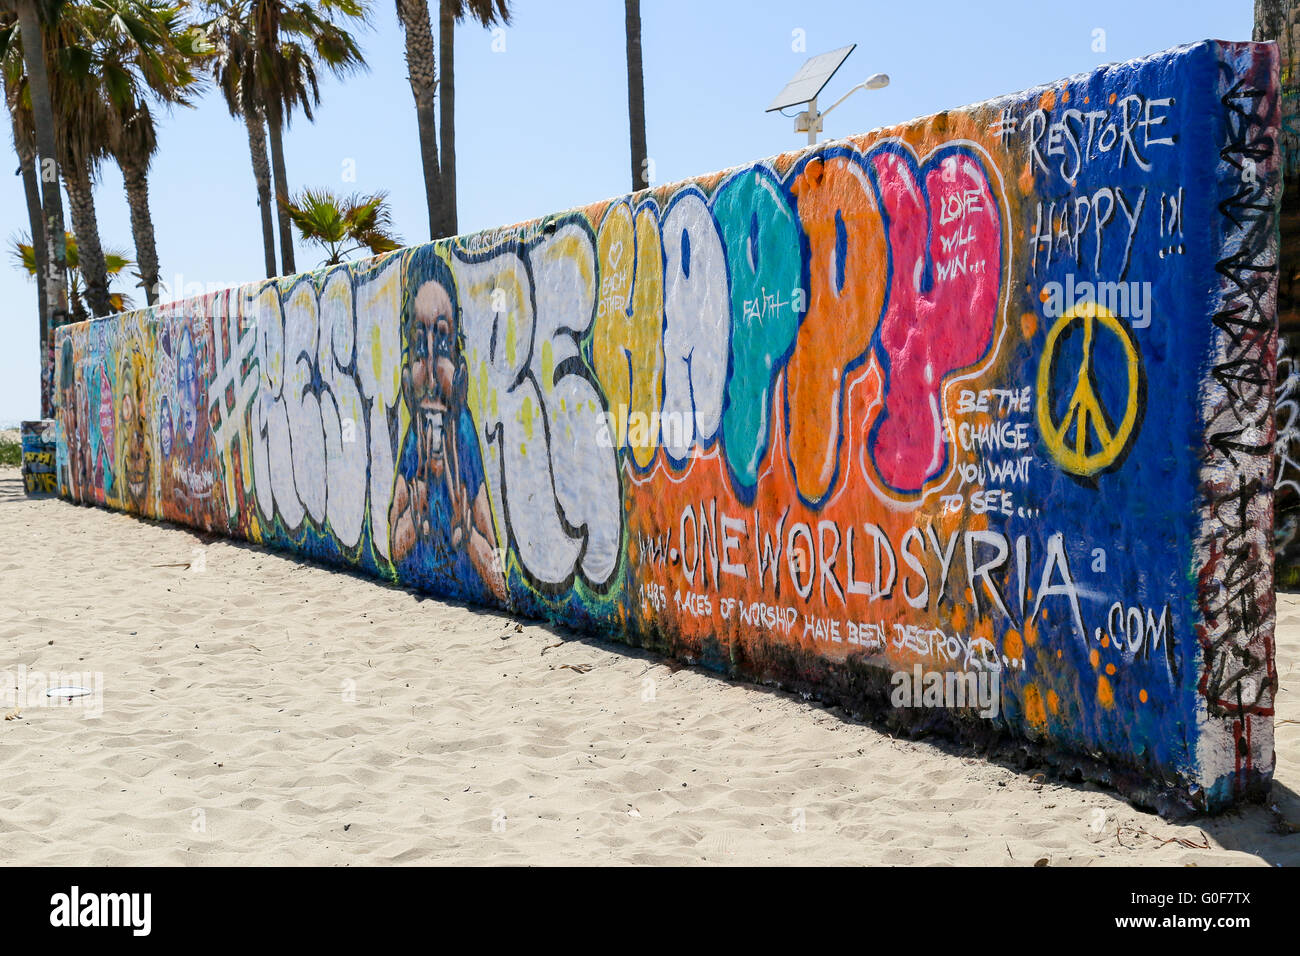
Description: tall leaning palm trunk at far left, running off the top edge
xmin=14 ymin=0 xmax=68 ymax=418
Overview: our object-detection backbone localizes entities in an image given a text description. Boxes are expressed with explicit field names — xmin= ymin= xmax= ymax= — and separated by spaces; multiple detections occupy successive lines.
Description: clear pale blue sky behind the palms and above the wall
xmin=0 ymin=0 xmax=1253 ymax=425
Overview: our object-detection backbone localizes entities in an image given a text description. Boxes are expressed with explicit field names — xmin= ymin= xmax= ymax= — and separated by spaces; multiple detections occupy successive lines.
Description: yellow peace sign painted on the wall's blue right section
xmin=1039 ymin=302 xmax=1141 ymax=475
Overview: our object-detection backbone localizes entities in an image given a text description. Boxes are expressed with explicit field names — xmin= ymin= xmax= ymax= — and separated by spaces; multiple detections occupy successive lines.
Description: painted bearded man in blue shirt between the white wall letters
xmin=390 ymin=250 xmax=506 ymax=602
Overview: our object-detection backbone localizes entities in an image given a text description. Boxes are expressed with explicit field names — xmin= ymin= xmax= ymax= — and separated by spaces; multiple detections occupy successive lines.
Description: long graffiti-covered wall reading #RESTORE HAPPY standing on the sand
xmin=56 ymin=43 xmax=1278 ymax=809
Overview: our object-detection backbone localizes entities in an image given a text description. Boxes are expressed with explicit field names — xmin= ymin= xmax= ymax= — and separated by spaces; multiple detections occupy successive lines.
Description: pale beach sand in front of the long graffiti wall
xmin=0 ymin=468 xmax=1300 ymax=866
